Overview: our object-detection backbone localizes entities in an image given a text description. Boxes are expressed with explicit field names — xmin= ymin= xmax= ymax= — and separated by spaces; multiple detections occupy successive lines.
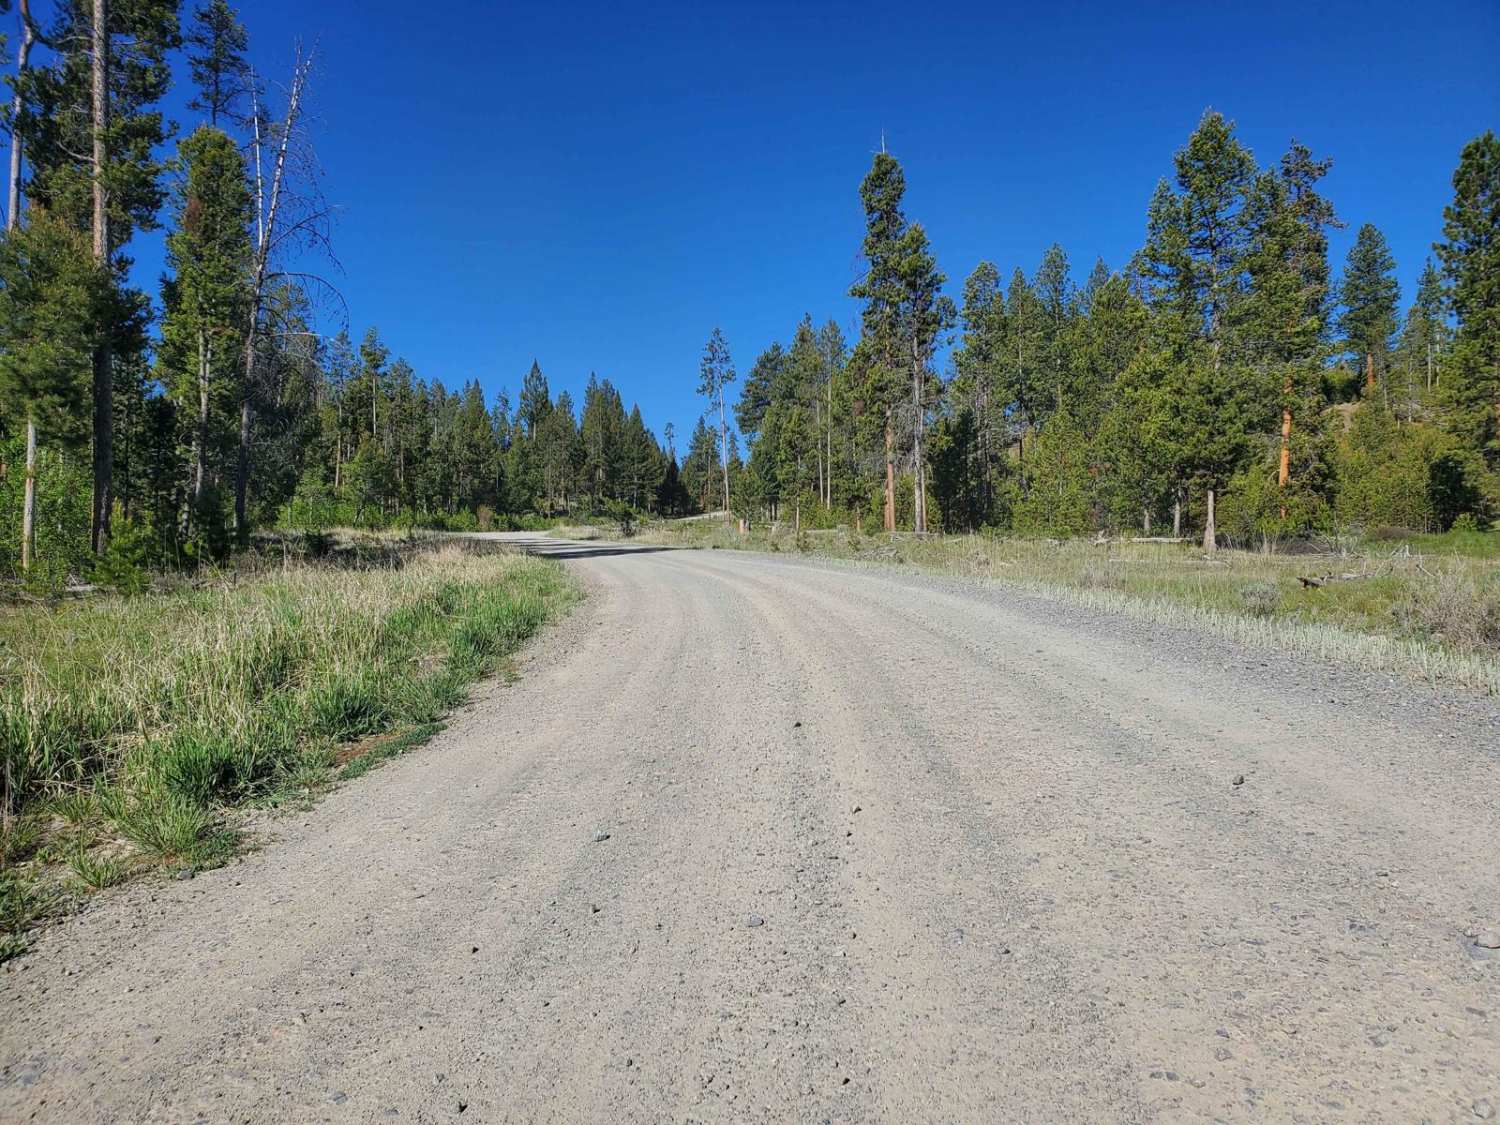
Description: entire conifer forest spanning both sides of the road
xmin=0 ymin=0 xmax=1500 ymax=600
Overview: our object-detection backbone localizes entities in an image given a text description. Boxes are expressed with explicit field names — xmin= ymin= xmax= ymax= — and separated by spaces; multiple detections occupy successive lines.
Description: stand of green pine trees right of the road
xmin=701 ymin=110 xmax=1500 ymax=549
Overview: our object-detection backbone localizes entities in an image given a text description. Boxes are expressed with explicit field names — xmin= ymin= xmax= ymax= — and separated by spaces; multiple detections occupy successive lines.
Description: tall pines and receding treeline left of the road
xmin=0 ymin=0 xmax=702 ymax=588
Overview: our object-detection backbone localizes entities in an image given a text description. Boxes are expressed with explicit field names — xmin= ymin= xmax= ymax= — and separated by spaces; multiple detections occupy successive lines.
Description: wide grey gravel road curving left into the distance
xmin=0 ymin=542 xmax=1500 ymax=1122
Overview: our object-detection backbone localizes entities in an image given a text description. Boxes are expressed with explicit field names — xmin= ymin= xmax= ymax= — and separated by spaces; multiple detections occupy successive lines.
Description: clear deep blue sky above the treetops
xmin=135 ymin=0 xmax=1500 ymax=449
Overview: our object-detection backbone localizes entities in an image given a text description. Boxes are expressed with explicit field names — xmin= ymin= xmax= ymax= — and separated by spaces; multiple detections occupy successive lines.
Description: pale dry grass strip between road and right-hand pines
xmin=641 ymin=521 xmax=1500 ymax=695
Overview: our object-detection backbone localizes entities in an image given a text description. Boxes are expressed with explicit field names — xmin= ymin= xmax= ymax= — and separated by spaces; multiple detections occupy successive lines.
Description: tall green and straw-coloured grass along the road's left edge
xmin=0 ymin=543 xmax=573 ymax=957
